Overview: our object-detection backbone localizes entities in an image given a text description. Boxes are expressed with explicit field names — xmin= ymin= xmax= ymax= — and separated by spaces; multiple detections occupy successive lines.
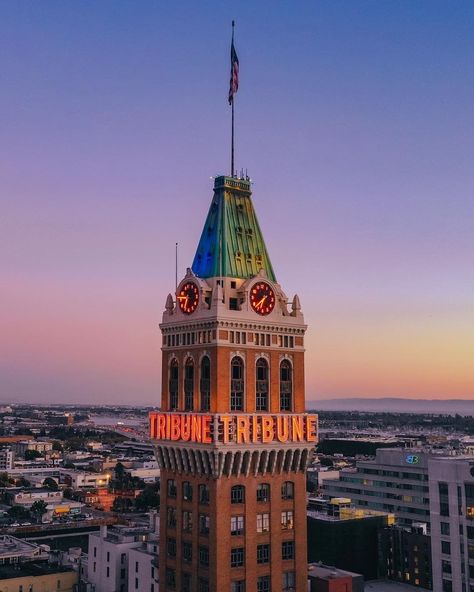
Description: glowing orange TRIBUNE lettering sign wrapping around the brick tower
xmin=150 ymin=413 xmax=318 ymax=444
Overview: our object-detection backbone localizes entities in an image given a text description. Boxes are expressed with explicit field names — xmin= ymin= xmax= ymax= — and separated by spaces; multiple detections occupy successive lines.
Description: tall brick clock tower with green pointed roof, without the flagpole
xmin=150 ymin=176 xmax=317 ymax=592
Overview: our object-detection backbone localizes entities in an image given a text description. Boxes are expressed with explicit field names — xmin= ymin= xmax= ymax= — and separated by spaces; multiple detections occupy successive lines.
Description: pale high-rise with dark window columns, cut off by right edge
xmin=428 ymin=456 xmax=474 ymax=592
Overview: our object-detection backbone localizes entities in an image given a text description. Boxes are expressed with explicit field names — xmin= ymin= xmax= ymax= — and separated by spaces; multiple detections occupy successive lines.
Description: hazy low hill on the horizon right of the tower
xmin=306 ymin=397 xmax=474 ymax=415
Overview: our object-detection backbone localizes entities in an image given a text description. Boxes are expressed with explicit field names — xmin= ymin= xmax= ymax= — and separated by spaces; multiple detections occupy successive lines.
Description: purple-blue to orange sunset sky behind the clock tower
xmin=0 ymin=0 xmax=474 ymax=404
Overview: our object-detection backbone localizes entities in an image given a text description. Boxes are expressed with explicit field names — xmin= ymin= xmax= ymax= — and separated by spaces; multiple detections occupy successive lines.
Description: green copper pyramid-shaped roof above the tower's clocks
xmin=192 ymin=177 xmax=276 ymax=281
